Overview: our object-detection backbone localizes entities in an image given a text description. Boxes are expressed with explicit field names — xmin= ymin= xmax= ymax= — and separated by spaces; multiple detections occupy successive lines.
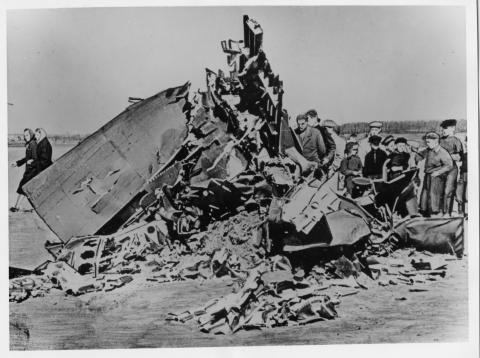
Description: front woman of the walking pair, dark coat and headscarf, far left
xmin=10 ymin=128 xmax=38 ymax=212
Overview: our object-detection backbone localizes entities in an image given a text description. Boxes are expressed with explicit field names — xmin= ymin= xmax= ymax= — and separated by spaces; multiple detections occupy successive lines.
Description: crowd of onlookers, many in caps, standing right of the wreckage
xmin=295 ymin=110 xmax=467 ymax=217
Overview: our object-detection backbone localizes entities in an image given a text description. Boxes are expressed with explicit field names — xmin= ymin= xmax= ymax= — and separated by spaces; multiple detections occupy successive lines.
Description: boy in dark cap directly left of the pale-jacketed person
xmin=384 ymin=137 xmax=418 ymax=217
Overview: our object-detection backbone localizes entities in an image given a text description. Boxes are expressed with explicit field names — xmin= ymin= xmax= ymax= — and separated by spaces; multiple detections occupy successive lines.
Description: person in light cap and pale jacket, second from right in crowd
xmin=416 ymin=132 xmax=453 ymax=217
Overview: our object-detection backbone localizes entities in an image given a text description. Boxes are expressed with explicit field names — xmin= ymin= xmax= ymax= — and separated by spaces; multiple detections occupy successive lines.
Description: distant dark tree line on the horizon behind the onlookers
xmin=339 ymin=119 xmax=467 ymax=135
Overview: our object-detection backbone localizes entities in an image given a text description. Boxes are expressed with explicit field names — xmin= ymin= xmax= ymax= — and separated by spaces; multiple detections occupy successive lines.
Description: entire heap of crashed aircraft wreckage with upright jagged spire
xmin=10 ymin=16 xmax=463 ymax=333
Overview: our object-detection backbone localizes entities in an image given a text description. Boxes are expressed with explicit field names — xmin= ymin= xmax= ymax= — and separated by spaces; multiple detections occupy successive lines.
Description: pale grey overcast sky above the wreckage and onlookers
xmin=7 ymin=6 xmax=466 ymax=133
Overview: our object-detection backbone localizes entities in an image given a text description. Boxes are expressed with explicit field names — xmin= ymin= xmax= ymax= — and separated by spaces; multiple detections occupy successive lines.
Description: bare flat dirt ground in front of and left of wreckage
xmin=10 ymin=213 xmax=468 ymax=350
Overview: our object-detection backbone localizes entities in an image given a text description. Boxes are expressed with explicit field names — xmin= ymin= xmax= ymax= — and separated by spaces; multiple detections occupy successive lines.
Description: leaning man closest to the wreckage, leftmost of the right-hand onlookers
xmin=295 ymin=114 xmax=327 ymax=178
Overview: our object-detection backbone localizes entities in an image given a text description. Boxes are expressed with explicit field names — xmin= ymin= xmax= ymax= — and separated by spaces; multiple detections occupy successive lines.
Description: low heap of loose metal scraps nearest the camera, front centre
xmin=167 ymin=258 xmax=339 ymax=334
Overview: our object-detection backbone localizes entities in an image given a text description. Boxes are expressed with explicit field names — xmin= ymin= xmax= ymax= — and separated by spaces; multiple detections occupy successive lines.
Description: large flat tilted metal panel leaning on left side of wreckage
xmin=24 ymin=83 xmax=190 ymax=242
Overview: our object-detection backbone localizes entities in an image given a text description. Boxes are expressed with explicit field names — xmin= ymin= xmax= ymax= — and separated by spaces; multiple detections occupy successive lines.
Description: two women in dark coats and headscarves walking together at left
xmin=10 ymin=128 xmax=52 ymax=212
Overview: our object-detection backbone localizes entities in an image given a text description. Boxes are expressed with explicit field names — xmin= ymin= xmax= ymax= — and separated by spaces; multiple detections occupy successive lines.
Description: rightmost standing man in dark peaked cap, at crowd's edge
xmin=440 ymin=119 xmax=463 ymax=216
